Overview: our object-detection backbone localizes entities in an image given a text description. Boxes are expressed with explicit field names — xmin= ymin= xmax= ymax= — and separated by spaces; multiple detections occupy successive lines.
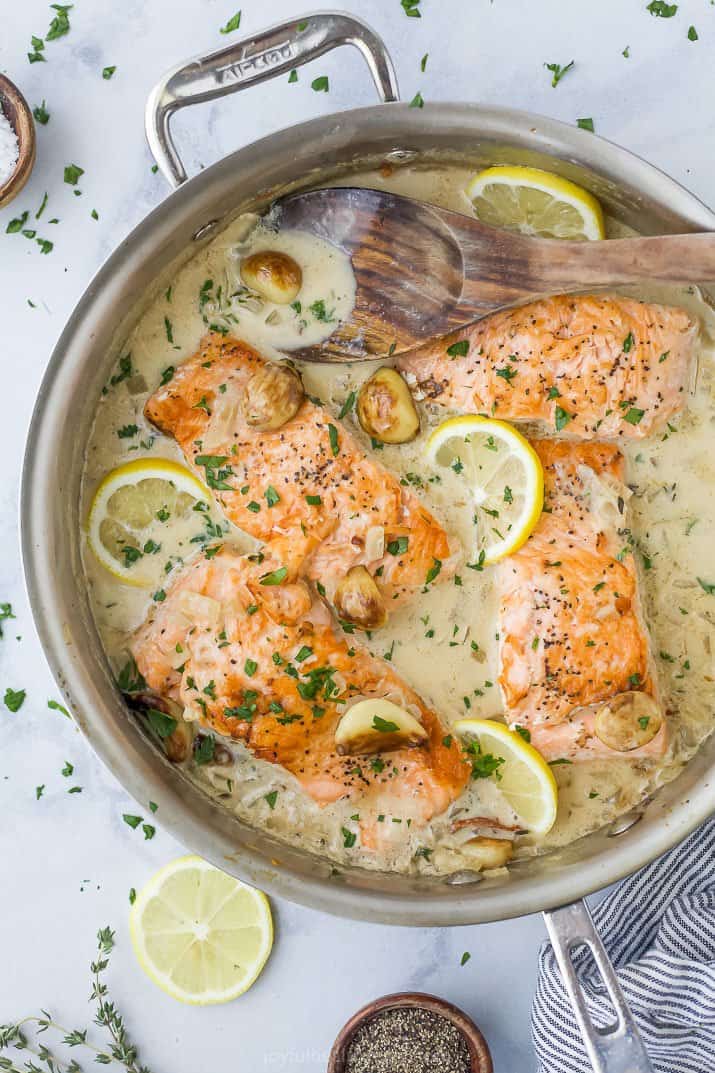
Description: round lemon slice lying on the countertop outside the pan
xmin=129 ymin=857 xmax=273 ymax=1005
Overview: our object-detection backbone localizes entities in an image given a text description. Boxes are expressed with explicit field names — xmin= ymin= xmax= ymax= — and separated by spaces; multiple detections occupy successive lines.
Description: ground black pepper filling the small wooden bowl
xmin=345 ymin=1006 xmax=471 ymax=1073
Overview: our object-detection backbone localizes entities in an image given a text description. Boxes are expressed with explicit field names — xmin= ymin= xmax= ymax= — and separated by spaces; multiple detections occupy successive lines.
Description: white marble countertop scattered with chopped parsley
xmin=0 ymin=0 xmax=715 ymax=1073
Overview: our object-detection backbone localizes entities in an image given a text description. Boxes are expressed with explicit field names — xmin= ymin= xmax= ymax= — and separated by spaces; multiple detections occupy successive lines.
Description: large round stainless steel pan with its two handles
xmin=21 ymin=13 xmax=715 ymax=1073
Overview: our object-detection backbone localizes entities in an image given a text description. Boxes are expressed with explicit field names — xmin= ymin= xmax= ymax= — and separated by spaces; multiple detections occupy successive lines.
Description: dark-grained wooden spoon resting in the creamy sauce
xmin=276 ymin=187 xmax=715 ymax=362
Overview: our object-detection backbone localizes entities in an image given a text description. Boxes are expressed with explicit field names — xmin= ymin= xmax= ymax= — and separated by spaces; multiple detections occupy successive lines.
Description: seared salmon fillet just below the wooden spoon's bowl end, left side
xmin=145 ymin=333 xmax=457 ymax=601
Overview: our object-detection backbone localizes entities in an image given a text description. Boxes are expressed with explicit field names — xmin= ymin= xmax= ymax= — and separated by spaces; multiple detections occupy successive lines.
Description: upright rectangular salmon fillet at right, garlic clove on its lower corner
xmin=498 ymin=440 xmax=667 ymax=760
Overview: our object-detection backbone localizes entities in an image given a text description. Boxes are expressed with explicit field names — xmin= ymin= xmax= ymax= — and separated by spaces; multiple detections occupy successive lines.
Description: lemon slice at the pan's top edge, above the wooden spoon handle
xmin=466 ymin=167 xmax=605 ymax=241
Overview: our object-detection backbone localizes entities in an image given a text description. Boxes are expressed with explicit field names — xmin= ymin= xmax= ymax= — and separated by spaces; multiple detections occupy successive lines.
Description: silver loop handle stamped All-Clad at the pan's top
xmin=145 ymin=11 xmax=399 ymax=187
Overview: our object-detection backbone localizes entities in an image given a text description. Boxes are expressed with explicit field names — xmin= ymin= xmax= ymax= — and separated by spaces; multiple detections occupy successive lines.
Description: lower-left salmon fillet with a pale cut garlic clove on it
xmin=130 ymin=546 xmax=469 ymax=823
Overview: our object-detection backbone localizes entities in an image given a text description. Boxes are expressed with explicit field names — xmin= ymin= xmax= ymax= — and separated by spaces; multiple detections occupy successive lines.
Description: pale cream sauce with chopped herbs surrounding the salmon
xmin=83 ymin=167 xmax=715 ymax=871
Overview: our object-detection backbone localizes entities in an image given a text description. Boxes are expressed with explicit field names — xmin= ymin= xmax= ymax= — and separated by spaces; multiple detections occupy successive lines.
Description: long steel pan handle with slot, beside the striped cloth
xmin=543 ymin=901 xmax=653 ymax=1073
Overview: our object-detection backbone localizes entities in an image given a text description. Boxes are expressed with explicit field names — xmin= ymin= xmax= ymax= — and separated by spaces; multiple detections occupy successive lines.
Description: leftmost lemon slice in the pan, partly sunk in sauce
xmin=87 ymin=458 xmax=209 ymax=585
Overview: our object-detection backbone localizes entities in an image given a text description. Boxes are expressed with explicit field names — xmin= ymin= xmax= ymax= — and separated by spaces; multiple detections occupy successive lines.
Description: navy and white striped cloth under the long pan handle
xmin=531 ymin=820 xmax=715 ymax=1073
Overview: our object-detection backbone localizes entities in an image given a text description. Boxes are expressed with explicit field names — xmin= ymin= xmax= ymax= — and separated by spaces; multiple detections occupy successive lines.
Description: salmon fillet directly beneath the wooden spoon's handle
xmin=397 ymin=295 xmax=698 ymax=439
